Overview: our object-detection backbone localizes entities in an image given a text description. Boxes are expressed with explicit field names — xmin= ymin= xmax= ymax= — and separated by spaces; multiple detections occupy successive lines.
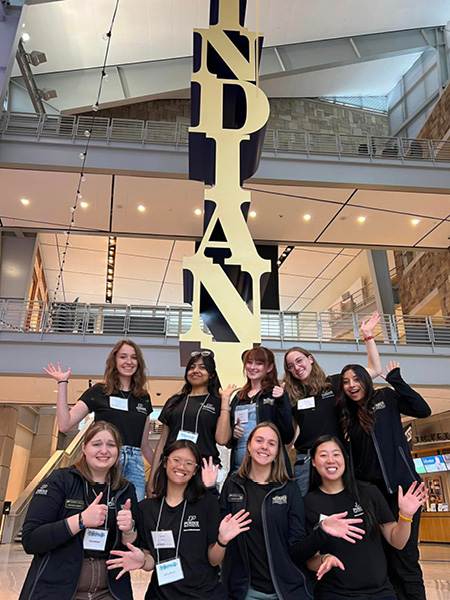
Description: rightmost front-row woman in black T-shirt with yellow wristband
xmin=305 ymin=435 xmax=427 ymax=600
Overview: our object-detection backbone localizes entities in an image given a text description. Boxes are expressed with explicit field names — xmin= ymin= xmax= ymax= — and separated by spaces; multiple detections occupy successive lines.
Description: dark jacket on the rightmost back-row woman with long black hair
xmin=350 ymin=368 xmax=431 ymax=494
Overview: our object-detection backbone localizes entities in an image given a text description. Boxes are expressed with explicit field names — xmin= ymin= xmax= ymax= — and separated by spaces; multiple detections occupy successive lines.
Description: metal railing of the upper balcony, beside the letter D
xmin=0 ymin=112 xmax=450 ymax=164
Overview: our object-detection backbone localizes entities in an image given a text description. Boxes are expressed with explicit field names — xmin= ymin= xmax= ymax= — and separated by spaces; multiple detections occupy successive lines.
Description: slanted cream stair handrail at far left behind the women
xmin=1 ymin=418 xmax=93 ymax=544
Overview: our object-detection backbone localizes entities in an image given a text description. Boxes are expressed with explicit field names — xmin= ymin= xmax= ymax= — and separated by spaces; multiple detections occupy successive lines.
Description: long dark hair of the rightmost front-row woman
xmin=309 ymin=435 xmax=380 ymax=537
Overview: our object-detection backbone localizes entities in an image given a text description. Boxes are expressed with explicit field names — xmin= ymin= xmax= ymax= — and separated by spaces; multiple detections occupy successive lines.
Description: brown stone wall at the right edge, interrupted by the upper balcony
xmin=394 ymin=84 xmax=450 ymax=316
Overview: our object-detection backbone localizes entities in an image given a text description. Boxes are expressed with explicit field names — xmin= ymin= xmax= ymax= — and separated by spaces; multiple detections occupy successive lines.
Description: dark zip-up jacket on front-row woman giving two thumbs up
xmin=19 ymin=467 xmax=137 ymax=600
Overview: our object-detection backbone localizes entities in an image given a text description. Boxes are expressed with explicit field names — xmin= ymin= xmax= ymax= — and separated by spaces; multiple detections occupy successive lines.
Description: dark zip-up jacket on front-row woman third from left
xmin=220 ymin=475 xmax=328 ymax=600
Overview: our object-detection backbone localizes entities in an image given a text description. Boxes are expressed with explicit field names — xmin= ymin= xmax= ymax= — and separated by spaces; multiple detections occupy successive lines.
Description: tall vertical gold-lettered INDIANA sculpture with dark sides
xmin=180 ymin=0 xmax=271 ymax=384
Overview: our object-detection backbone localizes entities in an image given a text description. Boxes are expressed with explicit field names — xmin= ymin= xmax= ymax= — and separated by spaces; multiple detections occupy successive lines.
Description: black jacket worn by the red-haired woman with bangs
xmin=227 ymin=392 xmax=295 ymax=475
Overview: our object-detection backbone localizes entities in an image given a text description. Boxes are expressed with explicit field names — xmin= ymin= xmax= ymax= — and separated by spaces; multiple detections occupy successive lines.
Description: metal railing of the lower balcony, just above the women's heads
xmin=0 ymin=300 xmax=450 ymax=347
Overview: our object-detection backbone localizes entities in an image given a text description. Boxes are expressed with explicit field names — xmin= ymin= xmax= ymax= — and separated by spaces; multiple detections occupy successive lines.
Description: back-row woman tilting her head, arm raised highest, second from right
xmin=284 ymin=312 xmax=382 ymax=496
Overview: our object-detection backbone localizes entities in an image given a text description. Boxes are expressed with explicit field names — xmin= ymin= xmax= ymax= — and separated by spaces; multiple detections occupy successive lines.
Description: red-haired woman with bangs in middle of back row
xmin=230 ymin=346 xmax=294 ymax=473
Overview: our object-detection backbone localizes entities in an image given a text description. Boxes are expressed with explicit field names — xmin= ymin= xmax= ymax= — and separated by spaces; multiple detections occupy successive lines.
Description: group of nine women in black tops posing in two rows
xmin=20 ymin=315 xmax=430 ymax=600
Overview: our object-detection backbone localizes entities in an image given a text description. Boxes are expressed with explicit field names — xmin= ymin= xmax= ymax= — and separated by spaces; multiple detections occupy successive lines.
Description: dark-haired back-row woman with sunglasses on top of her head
xmin=147 ymin=350 xmax=236 ymax=495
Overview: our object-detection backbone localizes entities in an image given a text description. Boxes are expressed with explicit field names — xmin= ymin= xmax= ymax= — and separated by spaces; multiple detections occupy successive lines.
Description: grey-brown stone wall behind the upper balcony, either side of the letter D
xmin=92 ymin=98 xmax=389 ymax=136
